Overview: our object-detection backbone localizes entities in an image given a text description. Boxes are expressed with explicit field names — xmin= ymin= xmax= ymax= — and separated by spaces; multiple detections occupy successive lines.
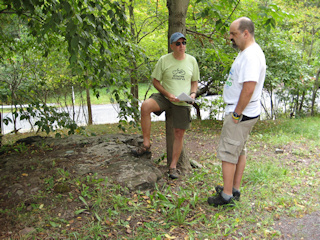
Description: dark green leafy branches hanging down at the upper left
xmin=0 ymin=0 xmax=127 ymax=124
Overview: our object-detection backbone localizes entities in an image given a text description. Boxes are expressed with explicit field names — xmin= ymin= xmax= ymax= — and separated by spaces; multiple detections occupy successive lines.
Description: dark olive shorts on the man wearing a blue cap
xmin=150 ymin=93 xmax=191 ymax=129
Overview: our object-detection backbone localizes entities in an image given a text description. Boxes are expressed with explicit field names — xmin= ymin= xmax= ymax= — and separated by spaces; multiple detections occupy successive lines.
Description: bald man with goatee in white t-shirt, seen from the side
xmin=208 ymin=17 xmax=266 ymax=206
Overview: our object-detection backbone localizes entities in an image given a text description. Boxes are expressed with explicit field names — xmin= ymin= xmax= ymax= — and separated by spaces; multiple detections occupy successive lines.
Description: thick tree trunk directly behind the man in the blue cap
xmin=166 ymin=0 xmax=191 ymax=174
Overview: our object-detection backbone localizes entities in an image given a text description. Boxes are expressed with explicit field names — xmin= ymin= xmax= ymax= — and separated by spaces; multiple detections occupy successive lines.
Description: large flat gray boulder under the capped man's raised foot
xmin=16 ymin=134 xmax=163 ymax=190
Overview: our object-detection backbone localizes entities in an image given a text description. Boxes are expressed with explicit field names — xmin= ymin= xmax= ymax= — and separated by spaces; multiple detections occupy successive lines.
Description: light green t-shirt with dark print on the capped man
xmin=151 ymin=53 xmax=200 ymax=106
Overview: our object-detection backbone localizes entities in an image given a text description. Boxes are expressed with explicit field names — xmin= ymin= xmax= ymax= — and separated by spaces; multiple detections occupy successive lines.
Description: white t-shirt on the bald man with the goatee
xmin=223 ymin=43 xmax=266 ymax=117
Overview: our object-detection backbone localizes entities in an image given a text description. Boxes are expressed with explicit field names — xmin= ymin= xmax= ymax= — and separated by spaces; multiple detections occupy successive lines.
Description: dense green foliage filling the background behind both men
xmin=0 ymin=0 xmax=320 ymax=135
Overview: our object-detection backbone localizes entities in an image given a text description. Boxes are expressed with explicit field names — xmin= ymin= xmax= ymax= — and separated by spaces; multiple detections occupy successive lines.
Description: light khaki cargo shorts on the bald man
xmin=217 ymin=114 xmax=258 ymax=164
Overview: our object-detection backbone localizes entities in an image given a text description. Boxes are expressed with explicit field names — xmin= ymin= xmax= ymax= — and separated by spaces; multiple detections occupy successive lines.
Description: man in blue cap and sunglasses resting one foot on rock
xmin=132 ymin=32 xmax=200 ymax=179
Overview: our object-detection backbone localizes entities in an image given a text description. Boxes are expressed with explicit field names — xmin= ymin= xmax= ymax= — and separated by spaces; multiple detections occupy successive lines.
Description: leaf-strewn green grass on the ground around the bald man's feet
xmin=0 ymin=117 xmax=320 ymax=240
